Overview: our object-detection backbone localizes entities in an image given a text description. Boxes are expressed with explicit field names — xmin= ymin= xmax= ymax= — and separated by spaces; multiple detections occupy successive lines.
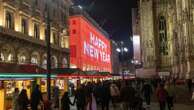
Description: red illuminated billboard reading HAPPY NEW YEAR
xmin=69 ymin=16 xmax=112 ymax=72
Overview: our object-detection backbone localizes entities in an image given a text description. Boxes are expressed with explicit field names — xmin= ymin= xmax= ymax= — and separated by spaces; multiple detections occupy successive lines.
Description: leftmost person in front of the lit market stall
xmin=12 ymin=88 xmax=19 ymax=110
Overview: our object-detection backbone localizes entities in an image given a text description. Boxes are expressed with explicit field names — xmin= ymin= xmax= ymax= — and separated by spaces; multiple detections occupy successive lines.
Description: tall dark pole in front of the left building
xmin=45 ymin=0 xmax=51 ymax=100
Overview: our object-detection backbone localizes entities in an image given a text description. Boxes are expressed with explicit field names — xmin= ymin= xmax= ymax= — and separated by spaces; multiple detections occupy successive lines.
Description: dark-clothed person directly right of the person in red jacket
xmin=166 ymin=83 xmax=176 ymax=110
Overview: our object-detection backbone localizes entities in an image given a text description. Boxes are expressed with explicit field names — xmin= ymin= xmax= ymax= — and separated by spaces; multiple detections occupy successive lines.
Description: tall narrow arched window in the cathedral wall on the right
xmin=159 ymin=16 xmax=168 ymax=55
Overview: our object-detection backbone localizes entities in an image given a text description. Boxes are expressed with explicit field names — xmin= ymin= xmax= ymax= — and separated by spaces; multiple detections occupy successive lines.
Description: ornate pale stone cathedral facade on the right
xmin=139 ymin=0 xmax=194 ymax=78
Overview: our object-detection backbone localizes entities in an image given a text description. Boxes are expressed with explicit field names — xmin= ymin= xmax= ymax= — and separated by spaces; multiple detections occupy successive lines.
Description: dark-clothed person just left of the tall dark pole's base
xmin=31 ymin=85 xmax=42 ymax=110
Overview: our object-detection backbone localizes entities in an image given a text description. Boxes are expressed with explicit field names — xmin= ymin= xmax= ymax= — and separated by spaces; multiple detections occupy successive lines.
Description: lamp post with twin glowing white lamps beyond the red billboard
xmin=116 ymin=41 xmax=128 ymax=80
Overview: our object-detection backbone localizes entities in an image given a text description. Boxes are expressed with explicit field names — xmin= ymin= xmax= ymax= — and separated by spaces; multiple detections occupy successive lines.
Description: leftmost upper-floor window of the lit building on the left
xmin=5 ymin=12 xmax=14 ymax=29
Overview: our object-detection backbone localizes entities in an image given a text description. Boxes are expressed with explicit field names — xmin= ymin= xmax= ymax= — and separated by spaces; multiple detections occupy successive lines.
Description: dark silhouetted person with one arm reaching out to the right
xmin=61 ymin=92 xmax=74 ymax=110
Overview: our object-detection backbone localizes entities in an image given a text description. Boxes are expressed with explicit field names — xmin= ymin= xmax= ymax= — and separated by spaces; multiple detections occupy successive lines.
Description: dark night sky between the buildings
xmin=74 ymin=0 xmax=136 ymax=58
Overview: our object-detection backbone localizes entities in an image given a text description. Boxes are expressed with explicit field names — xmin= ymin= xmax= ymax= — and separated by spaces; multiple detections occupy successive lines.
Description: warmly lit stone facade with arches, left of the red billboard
xmin=0 ymin=0 xmax=72 ymax=68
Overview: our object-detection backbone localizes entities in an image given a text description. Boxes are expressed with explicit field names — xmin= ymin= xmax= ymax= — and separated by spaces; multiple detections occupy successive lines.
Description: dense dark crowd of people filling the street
xmin=13 ymin=80 xmax=186 ymax=110
